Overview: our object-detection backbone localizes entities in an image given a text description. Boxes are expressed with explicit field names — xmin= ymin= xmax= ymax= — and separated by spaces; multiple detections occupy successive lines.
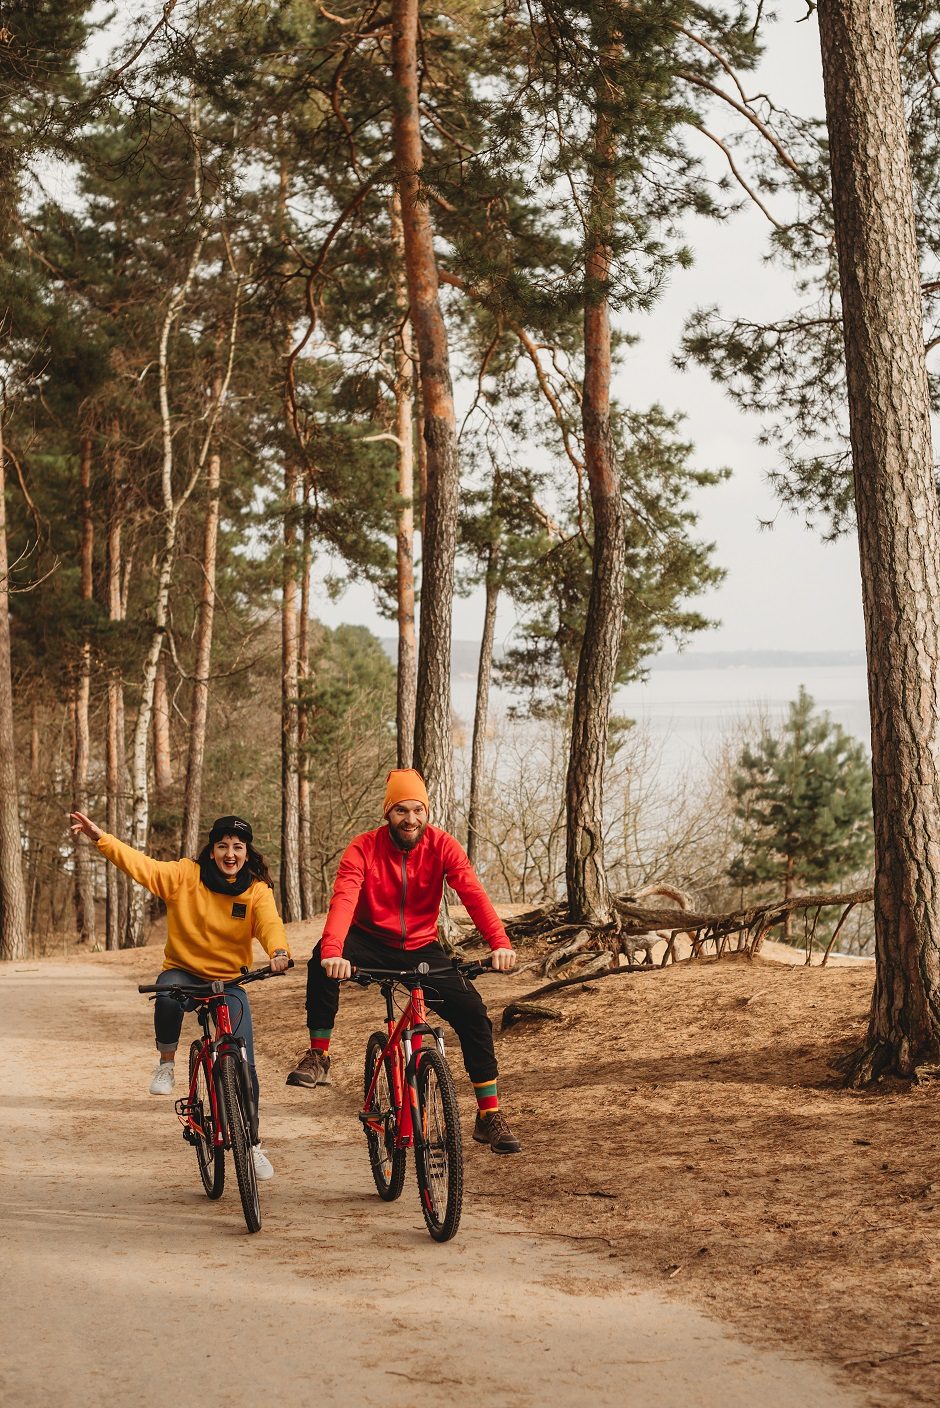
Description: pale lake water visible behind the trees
xmin=453 ymin=663 xmax=871 ymax=772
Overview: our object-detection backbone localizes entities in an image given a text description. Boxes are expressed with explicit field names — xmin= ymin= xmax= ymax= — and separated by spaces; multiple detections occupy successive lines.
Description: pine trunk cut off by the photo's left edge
xmin=0 ymin=421 xmax=28 ymax=959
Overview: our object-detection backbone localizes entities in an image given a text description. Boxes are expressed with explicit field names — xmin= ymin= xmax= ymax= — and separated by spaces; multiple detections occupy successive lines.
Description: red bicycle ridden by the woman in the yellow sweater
xmin=138 ymin=960 xmax=288 ymax=1232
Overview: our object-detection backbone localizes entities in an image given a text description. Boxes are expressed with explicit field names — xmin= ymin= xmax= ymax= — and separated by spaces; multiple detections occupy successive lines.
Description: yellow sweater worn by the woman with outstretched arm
xmin=97 ymin=835 xmax=290 ymax=977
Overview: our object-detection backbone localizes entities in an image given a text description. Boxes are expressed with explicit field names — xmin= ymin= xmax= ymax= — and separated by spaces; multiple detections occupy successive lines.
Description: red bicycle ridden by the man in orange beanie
xmin=352 ymin=963 xmax=490 ymax=1242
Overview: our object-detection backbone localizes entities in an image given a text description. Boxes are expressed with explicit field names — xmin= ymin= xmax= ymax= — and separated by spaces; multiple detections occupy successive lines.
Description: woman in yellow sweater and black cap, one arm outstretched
xmin=70 ymin=811 xmax=290 ymax=1178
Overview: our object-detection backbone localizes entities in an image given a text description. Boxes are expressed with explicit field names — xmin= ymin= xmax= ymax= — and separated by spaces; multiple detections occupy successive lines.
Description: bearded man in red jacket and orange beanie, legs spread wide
xmin=287 ymin=767 xmax=519 ymax=1153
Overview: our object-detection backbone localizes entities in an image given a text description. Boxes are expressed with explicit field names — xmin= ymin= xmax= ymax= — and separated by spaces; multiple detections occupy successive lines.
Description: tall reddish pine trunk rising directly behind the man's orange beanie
xmin=391 ymin=0 xmax=459 ymax=829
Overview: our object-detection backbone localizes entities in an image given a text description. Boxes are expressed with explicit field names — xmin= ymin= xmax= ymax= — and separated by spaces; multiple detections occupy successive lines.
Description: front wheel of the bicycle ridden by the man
xmin=415 ymin=1049 xmax=463 ymax=1242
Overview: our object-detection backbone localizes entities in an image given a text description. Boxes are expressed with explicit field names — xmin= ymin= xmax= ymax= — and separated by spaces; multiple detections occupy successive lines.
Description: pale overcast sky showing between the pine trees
xmin=314 ymin=8 xmax=923 ymax=650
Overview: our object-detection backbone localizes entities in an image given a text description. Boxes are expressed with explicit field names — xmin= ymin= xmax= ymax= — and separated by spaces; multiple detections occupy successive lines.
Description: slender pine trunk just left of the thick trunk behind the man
xmin=391 ymin=193 xmax=418 ymax=767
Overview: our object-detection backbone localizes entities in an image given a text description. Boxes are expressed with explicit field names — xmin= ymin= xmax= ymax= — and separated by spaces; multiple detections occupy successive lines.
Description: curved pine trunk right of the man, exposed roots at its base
xmin=566 ymin=88 xmax=626 ymax=924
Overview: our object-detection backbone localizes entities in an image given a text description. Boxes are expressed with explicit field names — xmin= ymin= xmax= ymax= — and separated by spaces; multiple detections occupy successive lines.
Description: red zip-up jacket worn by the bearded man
xmin=321 ymin=825 xmax=512 ymax=959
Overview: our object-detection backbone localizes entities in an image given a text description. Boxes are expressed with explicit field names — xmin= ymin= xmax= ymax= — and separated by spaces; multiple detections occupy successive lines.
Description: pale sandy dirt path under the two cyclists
xmin=0 ymin=955 xmax=864 ymax=1408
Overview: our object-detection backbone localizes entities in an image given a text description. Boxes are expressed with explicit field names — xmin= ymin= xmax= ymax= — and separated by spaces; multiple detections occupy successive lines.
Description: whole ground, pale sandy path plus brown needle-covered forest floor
xmin=0 ymin=925 xmax=940 ymax=1408
